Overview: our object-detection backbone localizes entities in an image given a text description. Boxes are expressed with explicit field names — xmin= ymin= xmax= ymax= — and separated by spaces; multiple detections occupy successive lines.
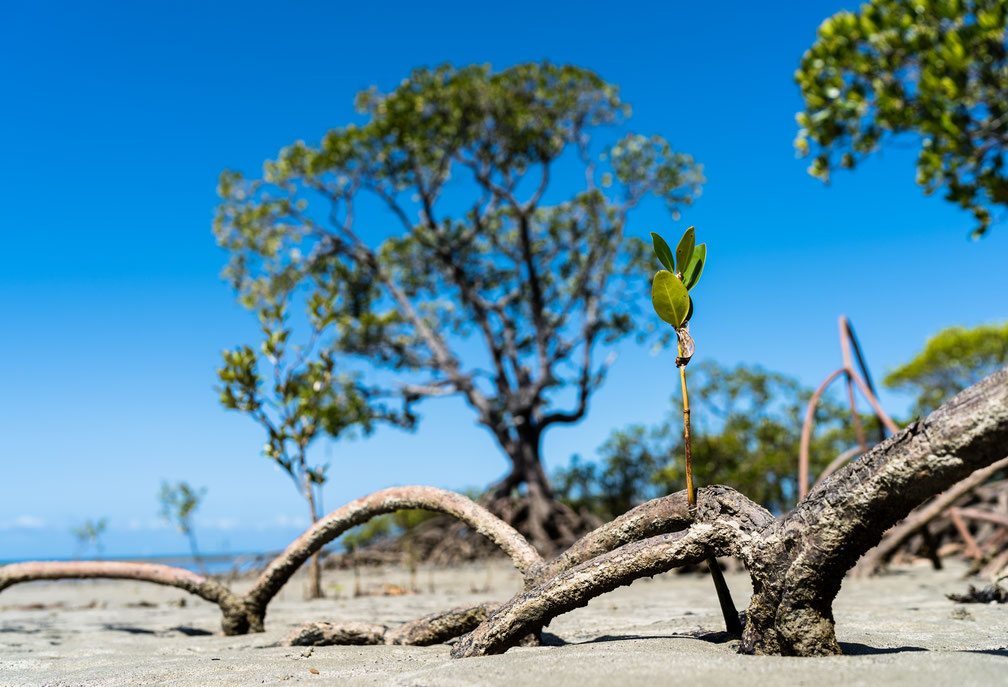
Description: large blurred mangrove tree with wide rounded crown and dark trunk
xmin=215 ymin=63 xmax=702 ymax=548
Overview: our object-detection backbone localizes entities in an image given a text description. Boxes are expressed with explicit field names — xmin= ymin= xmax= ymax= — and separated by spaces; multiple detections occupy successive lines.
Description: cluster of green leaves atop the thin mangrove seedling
xmin=651 ymin=227 xmax=707 ymax=329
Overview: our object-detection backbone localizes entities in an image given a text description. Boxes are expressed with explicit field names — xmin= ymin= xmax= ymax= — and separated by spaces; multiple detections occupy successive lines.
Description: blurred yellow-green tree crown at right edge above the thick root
xmin=883 ymin=322 xmax=1008 ymax=417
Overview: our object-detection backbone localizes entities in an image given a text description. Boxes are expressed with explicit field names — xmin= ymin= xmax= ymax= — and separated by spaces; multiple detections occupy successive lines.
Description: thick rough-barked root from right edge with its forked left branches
xmin=452 ymin=369 xmax=1008 ymax=658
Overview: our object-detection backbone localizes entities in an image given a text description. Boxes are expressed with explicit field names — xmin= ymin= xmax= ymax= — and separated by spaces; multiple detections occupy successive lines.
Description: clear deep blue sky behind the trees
xmin=0 ymin=2 xmax=1008 ymax=559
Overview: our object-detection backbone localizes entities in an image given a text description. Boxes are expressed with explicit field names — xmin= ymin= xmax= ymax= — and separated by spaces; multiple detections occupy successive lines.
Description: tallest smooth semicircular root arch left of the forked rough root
xmin=246 ymin=487 xmax=542 ymax=614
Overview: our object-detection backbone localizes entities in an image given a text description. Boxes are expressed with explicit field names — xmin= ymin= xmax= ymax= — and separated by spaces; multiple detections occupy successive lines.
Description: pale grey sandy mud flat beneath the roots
xmin=0 ymin=563 xmax=1008 ymax=687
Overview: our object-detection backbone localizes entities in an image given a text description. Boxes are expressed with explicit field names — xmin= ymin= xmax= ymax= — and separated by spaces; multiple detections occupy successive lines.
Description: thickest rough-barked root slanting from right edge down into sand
xmin=741 ymin=369 xmax=1008 ymax=656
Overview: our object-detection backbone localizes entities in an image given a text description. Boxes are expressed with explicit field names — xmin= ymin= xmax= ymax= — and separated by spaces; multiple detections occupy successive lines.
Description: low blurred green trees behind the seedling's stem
xmin=554 ymin=362 xmax=869 ymax=519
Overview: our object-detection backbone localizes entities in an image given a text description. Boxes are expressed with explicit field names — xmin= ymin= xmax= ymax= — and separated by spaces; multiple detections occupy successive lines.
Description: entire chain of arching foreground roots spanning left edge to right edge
xmin=0 ymin=368 xmax=1008 ymax=657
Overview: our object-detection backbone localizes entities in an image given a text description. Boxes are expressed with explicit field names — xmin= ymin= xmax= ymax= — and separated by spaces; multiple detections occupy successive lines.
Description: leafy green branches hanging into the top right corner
xmin=795 ymin=0 xmax=1008 ymax=236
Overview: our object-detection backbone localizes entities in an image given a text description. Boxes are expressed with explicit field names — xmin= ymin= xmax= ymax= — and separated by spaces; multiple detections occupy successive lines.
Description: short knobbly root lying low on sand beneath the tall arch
xmin=280 ymin=601 xmax=500 ymax=647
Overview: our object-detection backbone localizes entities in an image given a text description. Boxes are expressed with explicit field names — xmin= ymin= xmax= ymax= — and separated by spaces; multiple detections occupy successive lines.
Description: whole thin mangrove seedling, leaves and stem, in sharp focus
xmin=651 ymin=227 xmax=742 ymax=636
